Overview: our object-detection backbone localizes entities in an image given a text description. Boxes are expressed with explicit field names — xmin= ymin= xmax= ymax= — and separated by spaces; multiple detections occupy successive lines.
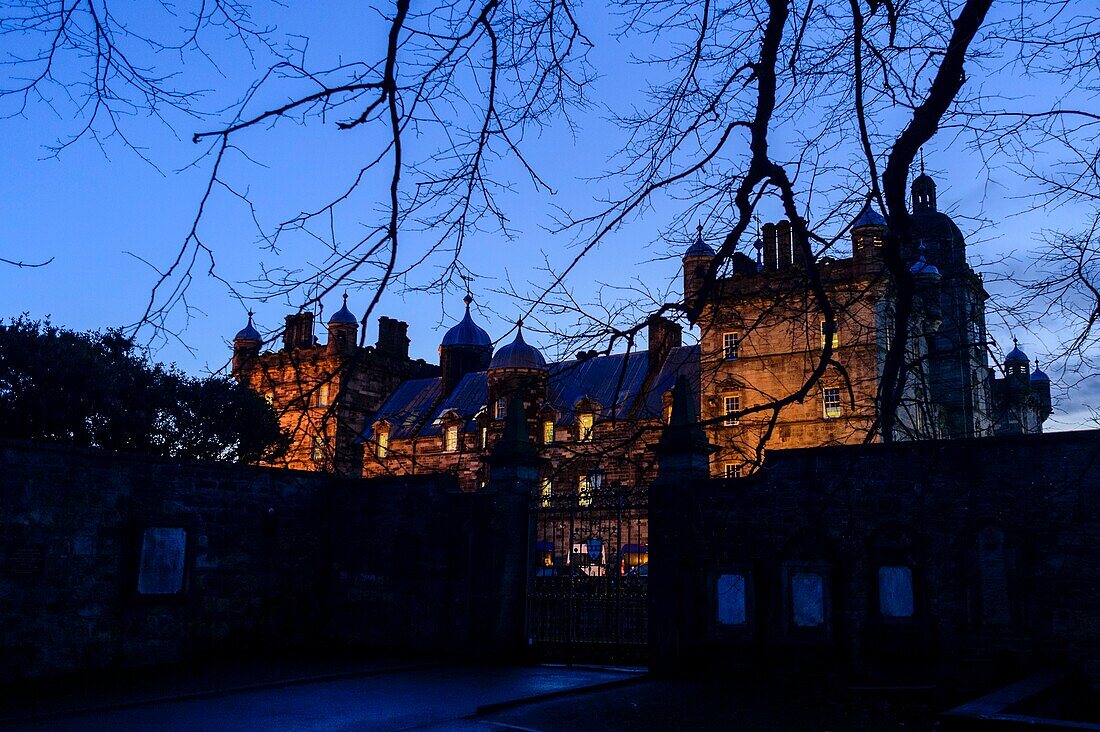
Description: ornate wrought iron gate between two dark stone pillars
xmin=527 ymin=489 xmax=649 ymax=663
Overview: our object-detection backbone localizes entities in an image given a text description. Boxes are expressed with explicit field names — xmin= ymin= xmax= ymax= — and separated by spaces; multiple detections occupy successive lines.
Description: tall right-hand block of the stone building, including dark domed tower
xmin=683 ymin=173 xmax=1051 ymax=477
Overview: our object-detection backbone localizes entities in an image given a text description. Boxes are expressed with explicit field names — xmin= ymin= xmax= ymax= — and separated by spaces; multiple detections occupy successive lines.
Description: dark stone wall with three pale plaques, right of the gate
xmin=650 ymin=431 xmax=1100 ymax=681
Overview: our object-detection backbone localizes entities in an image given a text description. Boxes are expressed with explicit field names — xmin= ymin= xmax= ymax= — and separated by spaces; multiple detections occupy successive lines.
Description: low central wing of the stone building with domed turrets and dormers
xmin=362 ymin=296 xmax=697 ymax=497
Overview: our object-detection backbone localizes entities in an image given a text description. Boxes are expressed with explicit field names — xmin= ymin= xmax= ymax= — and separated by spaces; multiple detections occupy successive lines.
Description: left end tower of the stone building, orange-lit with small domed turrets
xmin=232 ymin=295 xmax=439 ymax=476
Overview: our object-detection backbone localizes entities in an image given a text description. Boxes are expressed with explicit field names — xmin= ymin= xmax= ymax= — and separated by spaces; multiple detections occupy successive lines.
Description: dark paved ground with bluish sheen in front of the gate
xmin=0 ymin=660 xmax=934 ymax=732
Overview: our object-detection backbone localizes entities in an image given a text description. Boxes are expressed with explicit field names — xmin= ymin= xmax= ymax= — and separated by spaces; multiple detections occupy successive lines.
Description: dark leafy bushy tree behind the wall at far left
xmin=0 ymin=318 xmax=286 ymax=462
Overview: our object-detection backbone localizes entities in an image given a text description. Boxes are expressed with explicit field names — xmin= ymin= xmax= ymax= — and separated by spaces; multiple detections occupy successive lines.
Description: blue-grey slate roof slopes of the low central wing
xmin=362 ymin=346 xmax=699 ymax=439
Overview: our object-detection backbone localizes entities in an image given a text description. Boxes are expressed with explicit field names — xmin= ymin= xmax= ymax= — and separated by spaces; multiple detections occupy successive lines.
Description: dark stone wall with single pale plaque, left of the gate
xmin=0 ymin=441 xmax=473 ymax=680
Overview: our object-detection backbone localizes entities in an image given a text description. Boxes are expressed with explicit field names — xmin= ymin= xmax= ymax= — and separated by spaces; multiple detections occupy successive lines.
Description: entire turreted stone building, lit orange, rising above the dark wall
xmin=233 ymin=172 xmax=1051 ymax=482
